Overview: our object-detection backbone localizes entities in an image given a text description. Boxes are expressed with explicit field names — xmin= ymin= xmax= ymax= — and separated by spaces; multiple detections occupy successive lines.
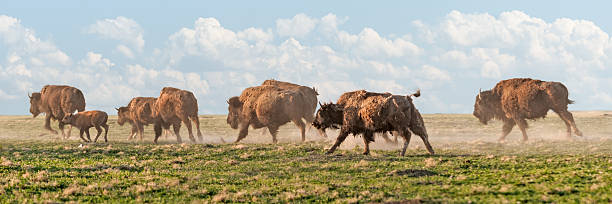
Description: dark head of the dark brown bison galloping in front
xmin=312 ymin=103 xmax=344 ymax=130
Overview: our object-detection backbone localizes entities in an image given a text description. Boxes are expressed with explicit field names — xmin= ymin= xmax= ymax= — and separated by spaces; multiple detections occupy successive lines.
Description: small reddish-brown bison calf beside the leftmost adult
xmin=62 ymin=110 xmax=108 ymax=143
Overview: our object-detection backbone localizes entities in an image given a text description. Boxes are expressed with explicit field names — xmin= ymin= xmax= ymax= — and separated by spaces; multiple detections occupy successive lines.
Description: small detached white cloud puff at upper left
xmin=87 ymin=16 xmax=145 ymax=54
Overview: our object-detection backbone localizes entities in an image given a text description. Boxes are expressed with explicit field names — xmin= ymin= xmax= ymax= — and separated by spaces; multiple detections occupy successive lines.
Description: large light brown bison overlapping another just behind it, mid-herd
xmin=227 ymin=85 xmax=306 ymax=143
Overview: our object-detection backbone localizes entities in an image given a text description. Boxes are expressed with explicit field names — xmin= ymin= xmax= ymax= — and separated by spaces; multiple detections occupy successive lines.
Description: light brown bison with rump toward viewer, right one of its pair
xmin=153 ymin=87 xmax=202 ymax=143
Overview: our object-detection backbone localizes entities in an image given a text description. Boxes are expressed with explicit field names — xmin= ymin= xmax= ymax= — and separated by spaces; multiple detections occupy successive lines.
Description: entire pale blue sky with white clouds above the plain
xmin=0 ymin=0 xmax=612 ymax=115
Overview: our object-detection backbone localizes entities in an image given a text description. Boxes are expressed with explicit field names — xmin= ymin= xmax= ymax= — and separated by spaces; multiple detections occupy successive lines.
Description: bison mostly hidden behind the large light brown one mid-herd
xmin=261 ymin=79 xmax=327 ymax=139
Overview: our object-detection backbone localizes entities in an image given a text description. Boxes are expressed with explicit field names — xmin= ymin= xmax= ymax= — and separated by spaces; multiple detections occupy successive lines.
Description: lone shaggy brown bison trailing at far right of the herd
xmin=474 ymin=78 xmax=582 ymax=142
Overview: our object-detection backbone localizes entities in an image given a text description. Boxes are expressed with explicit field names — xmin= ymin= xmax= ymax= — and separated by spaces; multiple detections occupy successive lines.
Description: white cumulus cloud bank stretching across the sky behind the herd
xmin=0 ymin=11 xmax=612 ymax=113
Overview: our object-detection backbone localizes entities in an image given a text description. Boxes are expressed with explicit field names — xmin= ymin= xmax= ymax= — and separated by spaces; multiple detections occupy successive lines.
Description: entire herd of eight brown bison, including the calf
xmin=29 ymin=78 xmax=582 ymax=156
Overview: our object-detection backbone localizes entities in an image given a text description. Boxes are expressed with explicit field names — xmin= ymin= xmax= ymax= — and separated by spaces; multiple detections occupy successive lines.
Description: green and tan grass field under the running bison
xmin=0 ymin=112 xmax=612 ymax=203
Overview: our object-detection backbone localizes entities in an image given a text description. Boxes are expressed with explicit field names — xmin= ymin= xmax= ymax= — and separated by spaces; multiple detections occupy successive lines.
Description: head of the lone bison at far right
xmin=473 ymin=90 xmax=501 ymax=125
